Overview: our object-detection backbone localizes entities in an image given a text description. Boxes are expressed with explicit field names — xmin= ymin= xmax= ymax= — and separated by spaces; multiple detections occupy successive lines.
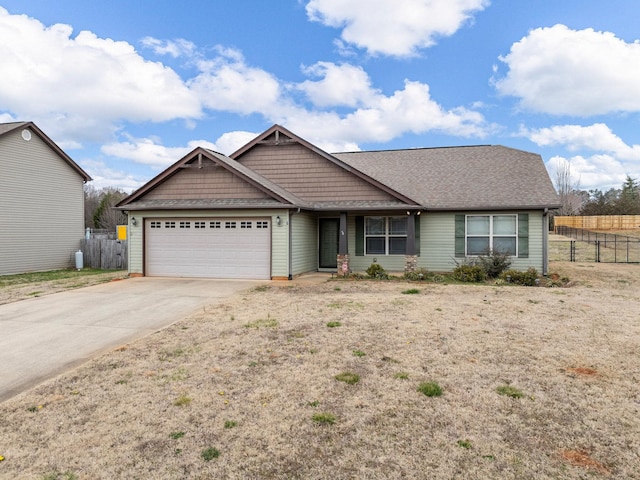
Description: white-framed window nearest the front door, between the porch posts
xmin=364 ymin=217 xmax=407 ymax=255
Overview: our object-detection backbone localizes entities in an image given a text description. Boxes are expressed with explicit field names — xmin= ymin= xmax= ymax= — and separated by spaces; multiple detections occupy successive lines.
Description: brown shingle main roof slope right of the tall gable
xmin=333 ymin=145 xmax=559 ymax=210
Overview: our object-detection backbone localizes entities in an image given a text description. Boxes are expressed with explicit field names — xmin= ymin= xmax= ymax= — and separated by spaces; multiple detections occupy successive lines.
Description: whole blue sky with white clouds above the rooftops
xmin=0 ymin=0 xmax=640 ymax=191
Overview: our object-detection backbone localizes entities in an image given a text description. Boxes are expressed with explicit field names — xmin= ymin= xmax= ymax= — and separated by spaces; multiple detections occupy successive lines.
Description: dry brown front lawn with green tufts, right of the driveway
xmin=0 ymin=263 xmax=640 ymax=479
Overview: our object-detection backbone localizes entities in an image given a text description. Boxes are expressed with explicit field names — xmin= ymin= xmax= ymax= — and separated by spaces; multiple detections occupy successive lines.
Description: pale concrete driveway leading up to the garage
xmin=0 ymin=277 xmax=264 ymax=401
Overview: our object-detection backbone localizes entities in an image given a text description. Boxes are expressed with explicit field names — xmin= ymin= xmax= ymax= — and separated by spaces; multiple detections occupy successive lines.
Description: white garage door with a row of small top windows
xmin=145 ymin=218 xmax=271 ymax=279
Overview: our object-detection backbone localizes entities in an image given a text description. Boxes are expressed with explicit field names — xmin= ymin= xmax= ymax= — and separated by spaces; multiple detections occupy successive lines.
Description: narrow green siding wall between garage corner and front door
xmin=290 ymin=213 xmax=318 ymax=275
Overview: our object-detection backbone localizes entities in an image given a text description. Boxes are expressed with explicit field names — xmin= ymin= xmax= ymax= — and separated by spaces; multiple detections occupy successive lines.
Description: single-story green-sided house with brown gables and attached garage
xmin=118 ymin=125 xmax=559 ymax=279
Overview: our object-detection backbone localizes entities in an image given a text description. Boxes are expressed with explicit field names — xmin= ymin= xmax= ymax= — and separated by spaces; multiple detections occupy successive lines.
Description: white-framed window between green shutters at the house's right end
xmin=465 ymin=215 xmax=518 ymax=256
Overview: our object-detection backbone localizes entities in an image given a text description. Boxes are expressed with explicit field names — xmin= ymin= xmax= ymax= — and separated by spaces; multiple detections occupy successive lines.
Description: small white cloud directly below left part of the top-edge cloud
xmin=297 ymin=62 xmax=377 ymax=107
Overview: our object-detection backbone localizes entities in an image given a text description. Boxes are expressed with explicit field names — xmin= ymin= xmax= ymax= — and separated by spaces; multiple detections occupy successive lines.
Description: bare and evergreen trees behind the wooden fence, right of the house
xmin=555 ymin=164 xmax=640 ymax=216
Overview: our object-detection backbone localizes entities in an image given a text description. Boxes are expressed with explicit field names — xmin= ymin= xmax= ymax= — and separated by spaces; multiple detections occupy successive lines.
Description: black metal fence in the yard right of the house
xmin=549 ymin=226 xmax=640 ymax=263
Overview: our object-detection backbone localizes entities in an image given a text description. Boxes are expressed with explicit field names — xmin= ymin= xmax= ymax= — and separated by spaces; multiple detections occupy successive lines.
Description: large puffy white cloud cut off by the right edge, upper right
xmin=495 ymin=25 xmax=640 ymax=116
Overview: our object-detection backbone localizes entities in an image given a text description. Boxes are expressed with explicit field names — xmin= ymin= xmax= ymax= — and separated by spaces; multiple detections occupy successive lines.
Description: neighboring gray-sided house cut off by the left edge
xmin=0 ymin=122 xmax=91 ymax=275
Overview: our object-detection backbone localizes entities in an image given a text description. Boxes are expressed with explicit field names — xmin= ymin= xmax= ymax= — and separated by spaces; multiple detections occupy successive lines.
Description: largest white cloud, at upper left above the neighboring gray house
xmin=0 ymin=7 xmax=201 ymax=142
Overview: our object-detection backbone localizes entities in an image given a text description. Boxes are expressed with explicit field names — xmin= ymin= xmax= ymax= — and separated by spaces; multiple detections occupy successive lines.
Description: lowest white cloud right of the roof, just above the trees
xmin=547 ymin=155 xmax=634 ymax=191
